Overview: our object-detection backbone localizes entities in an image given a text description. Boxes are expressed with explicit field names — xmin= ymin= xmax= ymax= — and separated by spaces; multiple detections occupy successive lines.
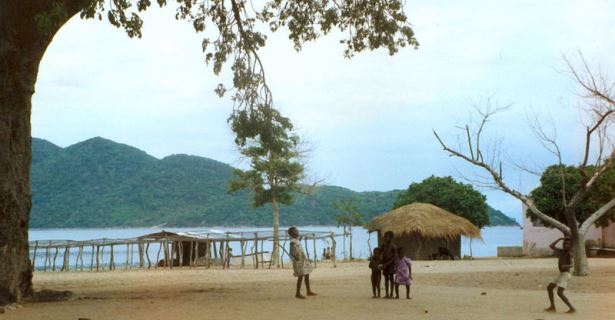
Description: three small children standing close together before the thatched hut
xmin=369 ymin=231 xmax=412 ymax=299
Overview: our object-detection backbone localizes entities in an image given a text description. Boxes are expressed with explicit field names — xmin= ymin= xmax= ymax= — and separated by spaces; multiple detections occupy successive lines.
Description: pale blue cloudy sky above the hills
xmin=32 ymin=0 xmax=615 ymax=220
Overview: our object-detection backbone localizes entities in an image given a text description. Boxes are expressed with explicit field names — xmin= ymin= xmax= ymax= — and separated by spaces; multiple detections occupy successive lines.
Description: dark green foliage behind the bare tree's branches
xmin=526 ymin=165 xmax=615 ymax=227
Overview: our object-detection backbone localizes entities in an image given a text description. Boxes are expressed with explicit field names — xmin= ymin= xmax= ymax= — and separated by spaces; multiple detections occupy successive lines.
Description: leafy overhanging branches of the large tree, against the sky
xmin=49 ymin=0 xmax=419 ymax=135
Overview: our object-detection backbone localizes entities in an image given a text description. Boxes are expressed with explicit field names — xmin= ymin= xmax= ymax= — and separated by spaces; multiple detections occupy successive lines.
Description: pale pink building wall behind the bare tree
xmin=522 ymin=205 xmax=615 ymax=257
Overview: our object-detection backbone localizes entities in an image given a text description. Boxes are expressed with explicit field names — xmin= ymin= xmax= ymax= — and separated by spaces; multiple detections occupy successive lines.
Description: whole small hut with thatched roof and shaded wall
xmin=365 ymin=202 xmax=480 ymax=260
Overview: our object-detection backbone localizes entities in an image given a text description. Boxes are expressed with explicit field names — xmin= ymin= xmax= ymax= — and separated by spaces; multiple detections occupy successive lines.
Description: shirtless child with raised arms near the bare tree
xmin=545 ymin=238 xmax=576 ymax=313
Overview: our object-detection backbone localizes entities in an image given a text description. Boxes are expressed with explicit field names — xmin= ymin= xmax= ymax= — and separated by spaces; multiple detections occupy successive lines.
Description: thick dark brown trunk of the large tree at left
xmin=0 ymin=0 xmax=76 ymax=305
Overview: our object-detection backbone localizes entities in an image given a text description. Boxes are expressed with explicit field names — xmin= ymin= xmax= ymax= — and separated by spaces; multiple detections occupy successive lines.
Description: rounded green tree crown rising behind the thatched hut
xmin=394 ymin=176 xmax=489 ymax=228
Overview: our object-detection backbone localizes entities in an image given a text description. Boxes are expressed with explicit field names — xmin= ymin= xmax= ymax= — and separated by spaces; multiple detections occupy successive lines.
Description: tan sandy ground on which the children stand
xmin=0 ymin=259 xmax=615 ymax=320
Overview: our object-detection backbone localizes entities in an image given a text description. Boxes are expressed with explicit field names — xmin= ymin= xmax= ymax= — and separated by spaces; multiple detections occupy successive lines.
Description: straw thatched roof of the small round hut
xmin=365 ymin=202 xmax=480 ymax=239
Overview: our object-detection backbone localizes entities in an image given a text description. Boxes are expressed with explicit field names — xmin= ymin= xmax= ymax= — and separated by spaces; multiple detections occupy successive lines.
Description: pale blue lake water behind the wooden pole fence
xmin=30 ymin=227 xmax=523 ymax=269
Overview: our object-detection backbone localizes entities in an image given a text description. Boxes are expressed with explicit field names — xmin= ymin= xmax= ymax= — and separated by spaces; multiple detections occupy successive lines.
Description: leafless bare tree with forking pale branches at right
xmin=433 ymin=54 xmax=615 ymax=275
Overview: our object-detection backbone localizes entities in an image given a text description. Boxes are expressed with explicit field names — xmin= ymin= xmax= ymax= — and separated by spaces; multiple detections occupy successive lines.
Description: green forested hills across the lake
xmin=30 ymin=138 xmax=514 ymax=228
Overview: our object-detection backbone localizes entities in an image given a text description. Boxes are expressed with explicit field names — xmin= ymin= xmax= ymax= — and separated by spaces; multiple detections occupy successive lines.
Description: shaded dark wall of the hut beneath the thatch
xmin=378 ymin=234 xmax=461 ymax=260
